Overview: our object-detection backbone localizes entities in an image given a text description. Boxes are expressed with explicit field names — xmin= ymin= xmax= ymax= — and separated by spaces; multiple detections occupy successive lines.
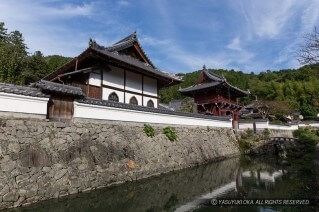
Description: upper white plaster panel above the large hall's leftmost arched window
xmin=103 ymin=66 xmax=124 ymax=89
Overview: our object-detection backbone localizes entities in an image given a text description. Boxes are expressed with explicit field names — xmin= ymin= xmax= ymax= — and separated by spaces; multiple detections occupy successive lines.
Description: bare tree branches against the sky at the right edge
xmin=297 ymin=27 xmax=319 ymax=65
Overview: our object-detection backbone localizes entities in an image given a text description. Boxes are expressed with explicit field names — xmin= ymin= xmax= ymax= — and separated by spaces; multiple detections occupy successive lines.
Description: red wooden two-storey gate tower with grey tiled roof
xmin=179 ymin=66 xmax=250 ymax=126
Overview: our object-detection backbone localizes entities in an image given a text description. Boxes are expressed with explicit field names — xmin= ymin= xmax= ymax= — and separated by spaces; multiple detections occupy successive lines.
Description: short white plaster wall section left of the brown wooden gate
xmin=0 ymin=93 xmax=49 ymax=115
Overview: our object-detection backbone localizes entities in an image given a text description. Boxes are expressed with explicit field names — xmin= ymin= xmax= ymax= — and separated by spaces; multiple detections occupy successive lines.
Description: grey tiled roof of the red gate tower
xmin=179 ymin=65 xmax=250 ymax=95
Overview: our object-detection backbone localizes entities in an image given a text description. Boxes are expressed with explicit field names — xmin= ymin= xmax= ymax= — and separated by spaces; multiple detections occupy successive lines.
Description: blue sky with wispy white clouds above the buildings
xmin=0 ymin=0 xmax=319 ymax=73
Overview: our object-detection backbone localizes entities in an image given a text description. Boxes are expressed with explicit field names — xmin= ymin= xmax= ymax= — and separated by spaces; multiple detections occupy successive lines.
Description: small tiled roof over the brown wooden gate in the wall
xmin=36 ymin=80 xmax=84 ymax=96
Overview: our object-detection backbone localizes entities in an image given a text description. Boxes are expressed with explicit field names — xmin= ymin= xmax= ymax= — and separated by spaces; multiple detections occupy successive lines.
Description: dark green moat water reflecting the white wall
xmin=5 ymin=158 xmax=319 ymax=212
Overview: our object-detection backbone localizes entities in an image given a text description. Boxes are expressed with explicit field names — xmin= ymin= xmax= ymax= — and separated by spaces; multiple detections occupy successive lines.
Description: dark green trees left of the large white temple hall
xmin=0 ymin=22 xmax=70 ymax=85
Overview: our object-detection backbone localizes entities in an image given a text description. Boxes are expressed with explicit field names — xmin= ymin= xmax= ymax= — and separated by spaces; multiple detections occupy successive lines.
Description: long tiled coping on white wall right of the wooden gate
xmin=76 ymin=98 xmax=230 ymax=121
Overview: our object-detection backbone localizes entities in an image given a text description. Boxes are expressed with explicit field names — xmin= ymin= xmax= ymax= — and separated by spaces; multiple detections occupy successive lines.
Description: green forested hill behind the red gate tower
xmin=160 ymin=64 xmax=319 ymax=117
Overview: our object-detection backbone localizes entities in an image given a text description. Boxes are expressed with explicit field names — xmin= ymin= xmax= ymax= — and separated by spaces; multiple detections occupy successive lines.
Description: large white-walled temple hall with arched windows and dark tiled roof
xmin=40 ymin=32 xmax=182 ymax=120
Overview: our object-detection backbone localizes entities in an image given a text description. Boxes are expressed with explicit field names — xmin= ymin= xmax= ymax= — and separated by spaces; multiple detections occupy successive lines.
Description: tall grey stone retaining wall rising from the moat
xmin=0 ymin=118 xmax=239 ymax=209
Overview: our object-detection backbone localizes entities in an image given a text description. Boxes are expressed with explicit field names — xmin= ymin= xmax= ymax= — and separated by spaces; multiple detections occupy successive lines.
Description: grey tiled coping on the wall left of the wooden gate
xmin=0 ymin=83 xmax=50 ymax=98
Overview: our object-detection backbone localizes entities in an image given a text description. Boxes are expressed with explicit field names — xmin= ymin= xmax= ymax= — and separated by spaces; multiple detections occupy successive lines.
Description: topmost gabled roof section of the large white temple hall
xmin=105 ymin=32 xmax=156 ymax=68
